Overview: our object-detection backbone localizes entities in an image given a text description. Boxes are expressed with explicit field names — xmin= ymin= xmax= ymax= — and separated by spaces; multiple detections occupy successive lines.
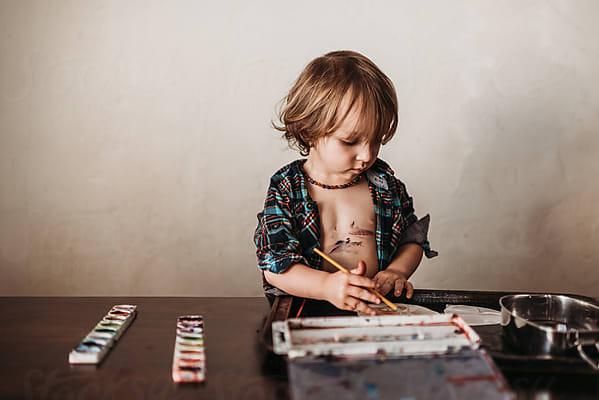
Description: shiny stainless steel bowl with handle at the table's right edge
xmin=499 ymin=294 xmax=599 ymax=369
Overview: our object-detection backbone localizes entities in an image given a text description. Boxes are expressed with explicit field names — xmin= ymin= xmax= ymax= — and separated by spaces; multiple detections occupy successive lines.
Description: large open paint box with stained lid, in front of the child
xmin=272 ymin=314 xmax=514 ymax=400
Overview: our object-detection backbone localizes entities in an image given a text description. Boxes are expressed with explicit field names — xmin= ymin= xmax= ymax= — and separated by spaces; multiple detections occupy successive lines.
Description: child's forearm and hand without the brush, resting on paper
xmin=373 ymin=243 xmax=424 ymax=299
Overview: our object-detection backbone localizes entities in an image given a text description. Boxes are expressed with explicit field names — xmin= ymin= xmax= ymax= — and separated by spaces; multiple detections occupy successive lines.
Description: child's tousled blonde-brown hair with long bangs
xmin=273 ymin=51 xmax=398 ymax=156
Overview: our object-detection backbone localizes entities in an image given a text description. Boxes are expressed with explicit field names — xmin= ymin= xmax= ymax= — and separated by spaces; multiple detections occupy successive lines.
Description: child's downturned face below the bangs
xmin=308 ymin=109 xmax=381 ymax=184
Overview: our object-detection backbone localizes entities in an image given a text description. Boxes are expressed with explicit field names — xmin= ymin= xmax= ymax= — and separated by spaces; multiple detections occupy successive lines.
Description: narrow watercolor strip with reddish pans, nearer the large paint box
xmin=172 ymin=315 xmax=206 ymax=382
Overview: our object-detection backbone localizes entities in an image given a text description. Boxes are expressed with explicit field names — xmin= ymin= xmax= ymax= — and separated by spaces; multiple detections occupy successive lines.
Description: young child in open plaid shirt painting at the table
xmin=254 ymin=51 xmax=437 ymax=315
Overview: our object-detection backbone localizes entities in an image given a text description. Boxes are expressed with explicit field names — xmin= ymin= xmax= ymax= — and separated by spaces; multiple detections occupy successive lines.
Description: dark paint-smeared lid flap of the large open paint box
xmin=288 ymin=349 xmax=515 ymax=400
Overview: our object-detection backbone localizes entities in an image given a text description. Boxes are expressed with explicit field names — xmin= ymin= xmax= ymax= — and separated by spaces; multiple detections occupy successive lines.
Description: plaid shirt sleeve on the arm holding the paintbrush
xmin=254 ymin=181 xmax=306 ymax=274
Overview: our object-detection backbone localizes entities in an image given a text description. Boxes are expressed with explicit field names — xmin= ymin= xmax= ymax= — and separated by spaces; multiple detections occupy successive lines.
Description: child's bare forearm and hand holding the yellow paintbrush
xmin=264 ymin=261 xmax=380 ymax=315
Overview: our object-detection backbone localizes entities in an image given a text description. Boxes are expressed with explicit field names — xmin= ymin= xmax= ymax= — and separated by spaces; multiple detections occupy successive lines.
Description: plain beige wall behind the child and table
xmin=0 ymin=0 xmax=599 ymax=296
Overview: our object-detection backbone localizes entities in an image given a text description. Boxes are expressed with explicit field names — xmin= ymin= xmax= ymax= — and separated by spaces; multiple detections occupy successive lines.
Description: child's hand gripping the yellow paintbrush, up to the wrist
xmin=323 ymin=261 xmax=381 ymax=315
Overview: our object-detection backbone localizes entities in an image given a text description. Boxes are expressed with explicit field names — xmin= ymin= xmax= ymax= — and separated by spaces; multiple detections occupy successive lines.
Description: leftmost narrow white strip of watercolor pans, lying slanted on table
xmin=69 ymin=304 xmax=137 ymax=364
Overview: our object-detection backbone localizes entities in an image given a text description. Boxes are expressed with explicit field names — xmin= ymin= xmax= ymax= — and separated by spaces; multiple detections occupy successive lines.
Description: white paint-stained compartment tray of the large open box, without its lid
xmin=272 ymin=314 xmax=480 ymax=359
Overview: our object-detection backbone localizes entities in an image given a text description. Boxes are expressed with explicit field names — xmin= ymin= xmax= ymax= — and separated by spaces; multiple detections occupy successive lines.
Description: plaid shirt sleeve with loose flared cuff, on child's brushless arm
xmin=396 ymin=180 xmax=439 ymax=258
